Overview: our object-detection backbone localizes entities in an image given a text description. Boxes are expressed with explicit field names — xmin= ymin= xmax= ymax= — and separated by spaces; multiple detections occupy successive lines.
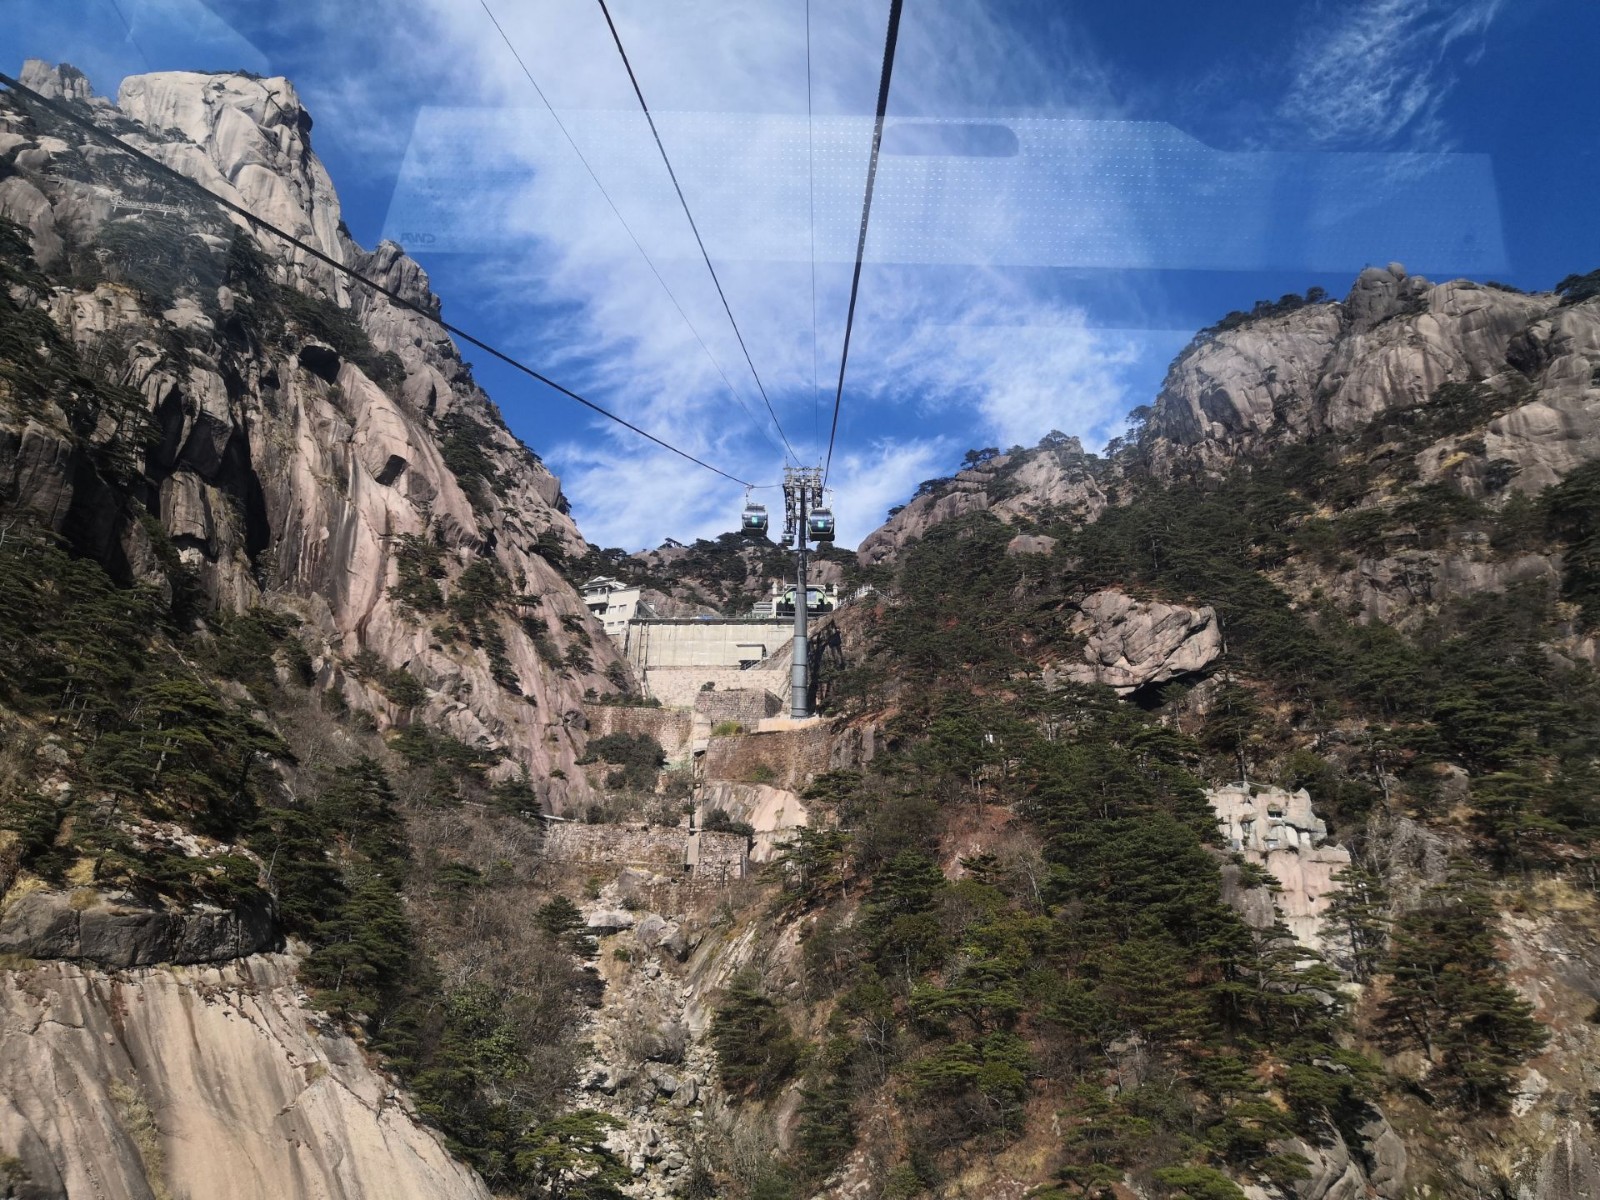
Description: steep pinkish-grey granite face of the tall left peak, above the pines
xmin=0 ymin=62 xmax=627 ymax=810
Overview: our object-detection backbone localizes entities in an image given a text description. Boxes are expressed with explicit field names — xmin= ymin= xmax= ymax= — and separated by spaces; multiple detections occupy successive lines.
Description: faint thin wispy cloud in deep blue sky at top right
xmin=1280 ymin=0 xmax=1502 ymax=149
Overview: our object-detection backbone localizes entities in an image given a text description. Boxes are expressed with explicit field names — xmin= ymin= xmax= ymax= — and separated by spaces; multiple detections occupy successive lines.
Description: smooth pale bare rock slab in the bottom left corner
xmin=0 ymin=955 xmax=488 ymax=1200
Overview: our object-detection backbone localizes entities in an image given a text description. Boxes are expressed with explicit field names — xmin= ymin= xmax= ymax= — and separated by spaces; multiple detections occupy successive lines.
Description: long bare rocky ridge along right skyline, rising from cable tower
xmin=861 ymin=264 xmax=1600 ymax=565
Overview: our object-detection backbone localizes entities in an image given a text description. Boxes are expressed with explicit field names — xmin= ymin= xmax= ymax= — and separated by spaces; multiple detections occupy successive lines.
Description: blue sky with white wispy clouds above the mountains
xmin=3 ymin=0 xmax=1600 ymax=549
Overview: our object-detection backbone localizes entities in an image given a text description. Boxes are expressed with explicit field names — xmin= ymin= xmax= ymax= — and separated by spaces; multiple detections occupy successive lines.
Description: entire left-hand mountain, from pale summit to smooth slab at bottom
xmin=0 ymin=62 xmax=630 ymax=1200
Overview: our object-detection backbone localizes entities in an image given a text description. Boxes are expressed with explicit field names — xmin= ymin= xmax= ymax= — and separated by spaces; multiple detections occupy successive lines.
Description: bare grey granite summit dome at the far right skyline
xmin=1139 ymin=262 xmax=1600 ymax=493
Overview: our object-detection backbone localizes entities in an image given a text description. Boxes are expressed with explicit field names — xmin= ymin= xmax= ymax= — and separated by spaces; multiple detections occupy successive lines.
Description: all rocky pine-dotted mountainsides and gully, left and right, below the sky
xmin=0 ymin=64 xmax=1600 ymax=1200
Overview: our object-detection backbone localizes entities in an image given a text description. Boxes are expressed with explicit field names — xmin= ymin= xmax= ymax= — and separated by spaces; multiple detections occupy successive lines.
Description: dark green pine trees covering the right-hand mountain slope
xmin=739 ymin=457 xmax=1574 ymax=1198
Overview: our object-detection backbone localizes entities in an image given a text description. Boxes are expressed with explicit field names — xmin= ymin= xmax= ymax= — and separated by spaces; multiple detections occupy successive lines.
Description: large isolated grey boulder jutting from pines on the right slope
xmin=1061 ymin=587 xmax=1222 ymax=694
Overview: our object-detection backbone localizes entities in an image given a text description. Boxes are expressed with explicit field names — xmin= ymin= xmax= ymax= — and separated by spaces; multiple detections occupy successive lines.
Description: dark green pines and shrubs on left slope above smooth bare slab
xmin=0 ymin=192 xmax=627 ymax=1198
